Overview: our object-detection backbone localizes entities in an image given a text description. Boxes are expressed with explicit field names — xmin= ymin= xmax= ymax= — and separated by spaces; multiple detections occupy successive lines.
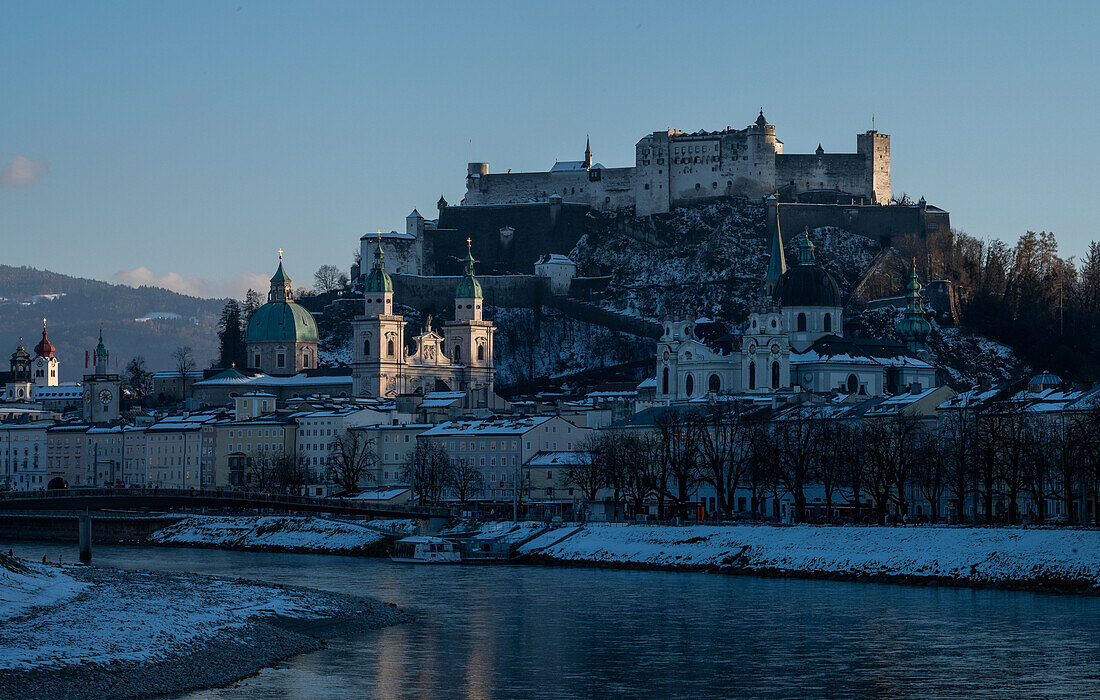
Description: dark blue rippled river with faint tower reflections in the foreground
xmin=3 ymin=544 xmax=1100 ymax=699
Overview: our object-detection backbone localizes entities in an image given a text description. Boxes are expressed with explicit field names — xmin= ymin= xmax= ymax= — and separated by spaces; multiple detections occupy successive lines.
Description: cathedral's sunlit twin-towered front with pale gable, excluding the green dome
xmin=352 ymin=240 xmax=495 ymax=396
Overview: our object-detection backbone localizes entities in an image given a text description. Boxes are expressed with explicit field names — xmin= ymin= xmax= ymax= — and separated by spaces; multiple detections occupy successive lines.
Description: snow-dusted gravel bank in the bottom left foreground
xmin=0 ymin=557 xmax=407 ymax=698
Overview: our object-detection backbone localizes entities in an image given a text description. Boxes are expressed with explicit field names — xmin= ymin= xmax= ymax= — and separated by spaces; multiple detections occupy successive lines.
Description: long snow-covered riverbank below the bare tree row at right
xmin=519 ymin=524 xmax=1100 ymax=593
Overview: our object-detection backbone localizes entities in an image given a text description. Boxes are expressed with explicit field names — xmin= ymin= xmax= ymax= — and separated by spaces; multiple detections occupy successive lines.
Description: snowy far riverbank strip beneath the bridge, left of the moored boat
xmin=146 ymin=515 xmax=417 ymax=555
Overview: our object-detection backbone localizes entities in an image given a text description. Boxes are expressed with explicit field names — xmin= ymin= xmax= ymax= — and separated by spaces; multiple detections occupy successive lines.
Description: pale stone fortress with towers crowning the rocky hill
xmin=462 ymin=110 xmax=890 ymax=217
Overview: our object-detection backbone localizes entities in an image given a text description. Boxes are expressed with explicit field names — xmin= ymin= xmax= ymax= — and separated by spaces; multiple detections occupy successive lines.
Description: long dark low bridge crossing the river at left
xmin=0 ymin=488 xmax=451 ymax=518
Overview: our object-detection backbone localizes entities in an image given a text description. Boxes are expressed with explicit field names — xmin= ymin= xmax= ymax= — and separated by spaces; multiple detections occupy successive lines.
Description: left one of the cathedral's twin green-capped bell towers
xmin=352 ymin=234 xmax=405 ymax=396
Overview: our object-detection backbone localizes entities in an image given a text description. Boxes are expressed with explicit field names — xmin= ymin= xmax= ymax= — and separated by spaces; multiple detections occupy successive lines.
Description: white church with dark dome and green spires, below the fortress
xmin=657 ymin=213 xmax=937 ymax=403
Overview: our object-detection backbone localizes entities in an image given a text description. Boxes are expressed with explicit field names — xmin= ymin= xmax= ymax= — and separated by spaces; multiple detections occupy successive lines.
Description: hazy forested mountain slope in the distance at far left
xmin=0 ymin=265 xmax=224 ymax=382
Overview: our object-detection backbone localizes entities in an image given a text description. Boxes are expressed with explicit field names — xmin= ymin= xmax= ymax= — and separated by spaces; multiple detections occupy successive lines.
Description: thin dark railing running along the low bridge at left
xmin=0 ymin=486 xmax=450 ymax=517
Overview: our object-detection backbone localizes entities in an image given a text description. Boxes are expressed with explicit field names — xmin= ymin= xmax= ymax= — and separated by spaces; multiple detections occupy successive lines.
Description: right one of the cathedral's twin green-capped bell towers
xmin=443 ymin=238 xmax=495 ymax=390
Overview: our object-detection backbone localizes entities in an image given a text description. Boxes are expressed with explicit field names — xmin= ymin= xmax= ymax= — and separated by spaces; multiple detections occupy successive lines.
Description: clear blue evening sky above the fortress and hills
xmin=0 ymin=0 xmax=1100 ymax=296
